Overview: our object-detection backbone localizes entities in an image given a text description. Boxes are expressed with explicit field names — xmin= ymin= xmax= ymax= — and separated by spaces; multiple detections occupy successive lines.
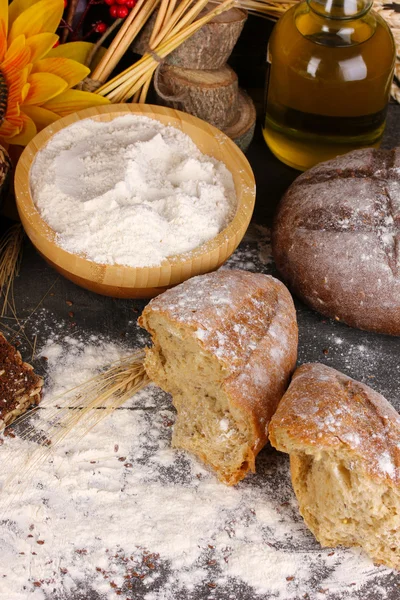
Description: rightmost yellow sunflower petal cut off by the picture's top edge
xmin=8 ymin=0 xmax=64 ymax=43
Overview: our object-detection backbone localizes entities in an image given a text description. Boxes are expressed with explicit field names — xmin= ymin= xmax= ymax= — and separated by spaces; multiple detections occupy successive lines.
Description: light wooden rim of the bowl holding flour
xmin=15 ymin=104 xmax=255 ymax=286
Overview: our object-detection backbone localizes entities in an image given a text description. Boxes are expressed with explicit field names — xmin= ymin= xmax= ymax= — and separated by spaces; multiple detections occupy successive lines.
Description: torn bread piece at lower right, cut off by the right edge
xmin=269 ymin=364 xmax=400 ymax=569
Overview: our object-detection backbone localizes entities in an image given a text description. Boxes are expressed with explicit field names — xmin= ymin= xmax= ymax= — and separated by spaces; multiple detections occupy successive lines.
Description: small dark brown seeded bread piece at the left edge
xmin=0 ymin=333 xmax=43 ymax=431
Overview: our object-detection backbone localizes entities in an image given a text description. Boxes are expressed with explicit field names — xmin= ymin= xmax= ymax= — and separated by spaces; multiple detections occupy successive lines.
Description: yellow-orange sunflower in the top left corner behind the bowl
xmin=0 ymin=0 xmax=108 ymax=146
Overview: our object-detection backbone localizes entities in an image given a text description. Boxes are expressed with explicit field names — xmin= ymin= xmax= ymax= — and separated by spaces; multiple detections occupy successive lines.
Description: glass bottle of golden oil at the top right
xmin=263 ymin=0 xmax=396 ymax=170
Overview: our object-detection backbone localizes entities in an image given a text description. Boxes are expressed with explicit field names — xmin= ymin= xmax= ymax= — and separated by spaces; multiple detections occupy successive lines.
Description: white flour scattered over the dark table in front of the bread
xmin=0 ymin=335 xmax=395 ymax=600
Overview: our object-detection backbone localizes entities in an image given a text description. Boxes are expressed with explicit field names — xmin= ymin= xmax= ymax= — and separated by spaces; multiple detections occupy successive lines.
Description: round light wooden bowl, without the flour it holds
xmin=15 ymin=104 xmax=255 ymax=298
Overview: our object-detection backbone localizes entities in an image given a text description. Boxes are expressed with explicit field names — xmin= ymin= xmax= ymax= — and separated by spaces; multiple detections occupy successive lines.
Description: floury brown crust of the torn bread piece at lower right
xmin=269 ymin=363 xmax=400 ymax=487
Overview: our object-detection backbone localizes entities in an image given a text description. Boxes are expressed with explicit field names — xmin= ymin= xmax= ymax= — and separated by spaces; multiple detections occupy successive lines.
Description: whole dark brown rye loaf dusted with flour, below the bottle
xmin=272 ymin=148 xmax=400 ymax=335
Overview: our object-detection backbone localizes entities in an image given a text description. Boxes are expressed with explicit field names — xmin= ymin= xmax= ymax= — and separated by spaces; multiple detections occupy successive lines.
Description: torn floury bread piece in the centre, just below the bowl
xmin=140 ymin=270 xmax=297 ymax=485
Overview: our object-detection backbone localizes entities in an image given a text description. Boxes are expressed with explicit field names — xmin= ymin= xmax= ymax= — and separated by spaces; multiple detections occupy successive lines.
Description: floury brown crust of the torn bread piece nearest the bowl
xmin=139 ymin=270 xmax=298 ymax=485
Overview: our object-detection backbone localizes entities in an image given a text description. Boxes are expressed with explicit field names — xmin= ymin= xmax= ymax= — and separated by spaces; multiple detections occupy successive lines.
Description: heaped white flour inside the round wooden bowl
xmin=30 ymin=115 xmax=236 ymax=267
